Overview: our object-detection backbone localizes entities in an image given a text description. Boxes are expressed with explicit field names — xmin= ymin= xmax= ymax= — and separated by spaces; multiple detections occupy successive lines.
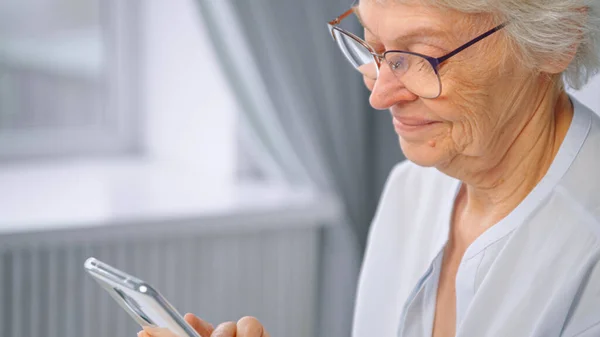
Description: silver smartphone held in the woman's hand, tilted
xmin=84 ymin=257 xmax=201 ymax=337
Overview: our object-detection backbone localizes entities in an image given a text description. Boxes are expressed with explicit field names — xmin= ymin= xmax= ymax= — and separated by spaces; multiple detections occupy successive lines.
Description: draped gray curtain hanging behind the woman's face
xmin=198 ymin=0 xmax=400 ymax=337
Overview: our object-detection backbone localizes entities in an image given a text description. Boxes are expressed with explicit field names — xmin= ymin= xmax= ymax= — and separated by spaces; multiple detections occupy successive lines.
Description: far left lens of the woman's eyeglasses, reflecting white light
xmin=333 ymin=29 xmax=379 ymax=80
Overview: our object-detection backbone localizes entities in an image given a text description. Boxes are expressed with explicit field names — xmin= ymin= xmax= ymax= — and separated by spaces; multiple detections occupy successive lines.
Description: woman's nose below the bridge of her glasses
xmin=369 ymin=60 xmax=419 ymax=110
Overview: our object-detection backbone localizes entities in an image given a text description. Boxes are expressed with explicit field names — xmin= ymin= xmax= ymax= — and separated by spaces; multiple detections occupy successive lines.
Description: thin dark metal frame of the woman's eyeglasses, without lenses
xmin=327 ymin=7 xmax=508 ymax=99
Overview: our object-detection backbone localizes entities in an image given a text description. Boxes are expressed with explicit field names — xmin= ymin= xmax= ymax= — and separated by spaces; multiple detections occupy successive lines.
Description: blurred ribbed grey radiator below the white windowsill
xmin=0 ymin=228 xmax=319 ymax=337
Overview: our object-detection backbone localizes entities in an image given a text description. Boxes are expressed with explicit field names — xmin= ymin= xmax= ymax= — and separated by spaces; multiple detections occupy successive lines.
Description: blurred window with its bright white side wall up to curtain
xmin=0 ymin=0 xmax=266 ymax=182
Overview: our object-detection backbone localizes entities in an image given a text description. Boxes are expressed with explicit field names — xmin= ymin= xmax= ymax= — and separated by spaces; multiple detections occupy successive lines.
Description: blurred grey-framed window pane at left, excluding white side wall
xmin=0 ymin=0 xmax=139 ymax=161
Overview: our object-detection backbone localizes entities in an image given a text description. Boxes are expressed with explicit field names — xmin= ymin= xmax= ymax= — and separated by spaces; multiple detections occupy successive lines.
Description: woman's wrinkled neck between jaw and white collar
xmin=442 ymin=86 xmax=573 ymax=226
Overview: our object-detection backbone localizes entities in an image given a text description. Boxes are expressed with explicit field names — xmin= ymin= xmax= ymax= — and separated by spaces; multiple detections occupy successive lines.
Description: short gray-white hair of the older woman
xmin=410 ymin=0 xmax=600 ymax=89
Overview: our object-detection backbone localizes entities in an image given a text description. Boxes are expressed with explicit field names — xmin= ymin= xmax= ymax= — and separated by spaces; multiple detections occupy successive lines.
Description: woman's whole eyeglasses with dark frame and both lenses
xmin=327 ymin=8 xmax=508 ymax=99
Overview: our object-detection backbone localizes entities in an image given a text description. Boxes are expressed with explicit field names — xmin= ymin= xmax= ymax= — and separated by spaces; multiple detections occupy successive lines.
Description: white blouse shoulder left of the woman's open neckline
xmin=353 ymin=161 xmax=453 ymax=336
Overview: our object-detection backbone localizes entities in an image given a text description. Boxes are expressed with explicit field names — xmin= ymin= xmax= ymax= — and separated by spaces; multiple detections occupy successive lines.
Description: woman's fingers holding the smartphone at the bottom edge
xmin=138 ymin=314 xmax=270 ymax=337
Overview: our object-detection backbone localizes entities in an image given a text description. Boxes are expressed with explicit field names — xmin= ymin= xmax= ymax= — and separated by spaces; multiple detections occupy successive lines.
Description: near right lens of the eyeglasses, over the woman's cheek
xmin=385 ymin=52 xmax=442 ymax=98
